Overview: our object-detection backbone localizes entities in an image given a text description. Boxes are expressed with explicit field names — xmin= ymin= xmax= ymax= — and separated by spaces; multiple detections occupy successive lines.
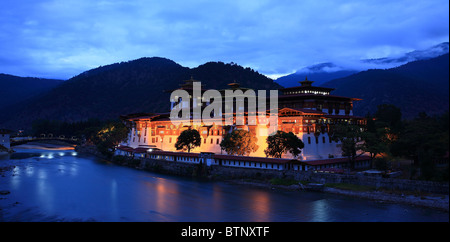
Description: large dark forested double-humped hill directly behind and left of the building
xmin=0 ymin=57 xmax=281 ymax=129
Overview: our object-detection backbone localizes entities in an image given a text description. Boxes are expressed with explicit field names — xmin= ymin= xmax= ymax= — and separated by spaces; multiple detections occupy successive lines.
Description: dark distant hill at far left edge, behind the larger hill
xmin=0 ymin=74 xmax=63 ymax=109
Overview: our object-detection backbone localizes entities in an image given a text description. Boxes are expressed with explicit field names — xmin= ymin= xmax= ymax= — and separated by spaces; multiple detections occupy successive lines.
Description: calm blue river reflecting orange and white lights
xmin=0 ymin=146 xmax=449 ymax=222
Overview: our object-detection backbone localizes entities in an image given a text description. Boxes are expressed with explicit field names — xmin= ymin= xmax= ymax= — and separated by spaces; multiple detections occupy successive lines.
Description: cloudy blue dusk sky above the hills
xmin=0 ymin=0 xmax=449 ymax=79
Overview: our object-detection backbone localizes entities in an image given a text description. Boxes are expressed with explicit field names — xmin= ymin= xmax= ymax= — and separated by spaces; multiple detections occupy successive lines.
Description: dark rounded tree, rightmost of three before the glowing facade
xmin=264 ymin=131 xmax=305 ymax=158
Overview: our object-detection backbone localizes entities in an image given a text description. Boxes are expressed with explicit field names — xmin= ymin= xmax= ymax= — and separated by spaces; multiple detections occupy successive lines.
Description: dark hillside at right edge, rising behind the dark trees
xmin=322 ymin=54 xmax=449 ymax=119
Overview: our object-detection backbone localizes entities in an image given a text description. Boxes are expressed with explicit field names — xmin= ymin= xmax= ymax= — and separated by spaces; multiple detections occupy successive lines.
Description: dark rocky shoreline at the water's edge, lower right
xmin=227 ymin=180 xmax=449 ymax=212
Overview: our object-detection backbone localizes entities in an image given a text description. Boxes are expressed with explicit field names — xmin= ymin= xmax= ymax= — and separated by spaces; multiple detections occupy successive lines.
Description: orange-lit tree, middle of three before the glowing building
xmin=220 ymin=129 xmax=259 ymax=155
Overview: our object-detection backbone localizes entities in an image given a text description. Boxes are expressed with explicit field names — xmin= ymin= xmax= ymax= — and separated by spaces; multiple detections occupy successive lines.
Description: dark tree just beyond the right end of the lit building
xmin=332 ymin=124 xmax=364 ymax=169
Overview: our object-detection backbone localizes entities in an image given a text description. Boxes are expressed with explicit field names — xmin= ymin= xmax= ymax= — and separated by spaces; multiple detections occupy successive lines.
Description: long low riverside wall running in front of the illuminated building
xmin=140 ymin=158 xmax=449 ymax=194
